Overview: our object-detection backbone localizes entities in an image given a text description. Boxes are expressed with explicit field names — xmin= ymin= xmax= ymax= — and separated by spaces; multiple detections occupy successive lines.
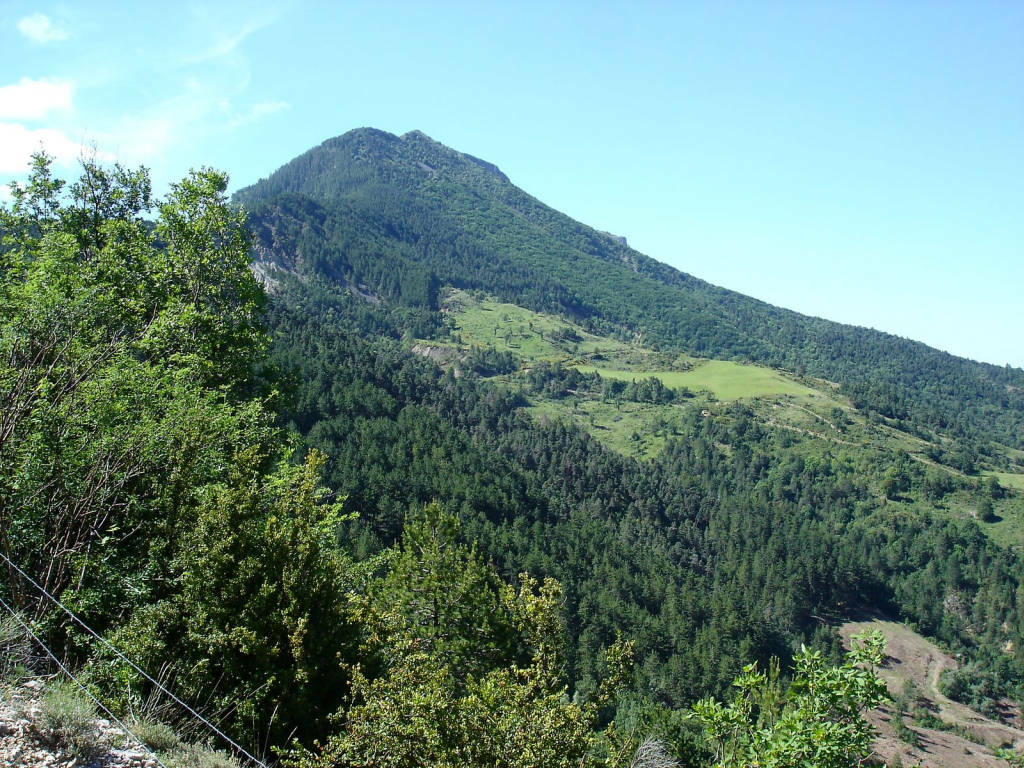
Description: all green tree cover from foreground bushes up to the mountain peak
xmin=6 ymin=145 xmax=1024 ymax=768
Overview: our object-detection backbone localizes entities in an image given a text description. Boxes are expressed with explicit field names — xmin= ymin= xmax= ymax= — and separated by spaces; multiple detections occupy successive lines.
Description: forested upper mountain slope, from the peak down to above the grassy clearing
xmin=236 ymin=129 xmax=1024 ymax=447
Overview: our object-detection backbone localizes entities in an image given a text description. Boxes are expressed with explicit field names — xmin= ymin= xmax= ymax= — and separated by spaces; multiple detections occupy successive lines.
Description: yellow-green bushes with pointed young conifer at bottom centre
xmin=290 ymin=505 xmax=630 ymax=768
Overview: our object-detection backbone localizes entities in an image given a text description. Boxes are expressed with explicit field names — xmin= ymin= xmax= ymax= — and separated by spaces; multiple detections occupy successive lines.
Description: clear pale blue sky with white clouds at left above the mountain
xmin=0 ymin=0 xmax=1024 ymax=367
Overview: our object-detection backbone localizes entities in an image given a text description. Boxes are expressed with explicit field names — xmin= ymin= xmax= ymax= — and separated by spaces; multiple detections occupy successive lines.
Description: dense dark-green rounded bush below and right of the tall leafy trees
xmin=105 ymin=452 xmax=359 ymax=742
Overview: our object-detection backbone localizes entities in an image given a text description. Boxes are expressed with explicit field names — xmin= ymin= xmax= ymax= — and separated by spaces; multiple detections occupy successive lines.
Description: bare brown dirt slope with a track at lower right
xmin=840 ymin=620 xmax=1024 ymax=768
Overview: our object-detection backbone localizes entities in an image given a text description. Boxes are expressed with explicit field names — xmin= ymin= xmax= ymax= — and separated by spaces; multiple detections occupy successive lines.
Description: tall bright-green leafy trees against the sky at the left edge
xmin=0 ymin=155 xmax=267 ymax=612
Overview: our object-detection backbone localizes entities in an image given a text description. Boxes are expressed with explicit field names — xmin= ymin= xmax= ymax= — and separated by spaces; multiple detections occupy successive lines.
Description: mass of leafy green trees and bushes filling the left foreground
xmin=0 ymin=156 xmax=358 ymax=757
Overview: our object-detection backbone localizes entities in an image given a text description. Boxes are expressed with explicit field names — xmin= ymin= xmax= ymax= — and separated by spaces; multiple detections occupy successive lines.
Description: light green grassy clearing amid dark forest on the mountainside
xmin=440 ymin=291 xmax=991 ymax=520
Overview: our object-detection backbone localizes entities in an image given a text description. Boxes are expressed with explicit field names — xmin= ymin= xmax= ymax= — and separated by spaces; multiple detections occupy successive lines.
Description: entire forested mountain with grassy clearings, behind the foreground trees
xmin=228 ymin=124 xmax=1024 ymax=753
